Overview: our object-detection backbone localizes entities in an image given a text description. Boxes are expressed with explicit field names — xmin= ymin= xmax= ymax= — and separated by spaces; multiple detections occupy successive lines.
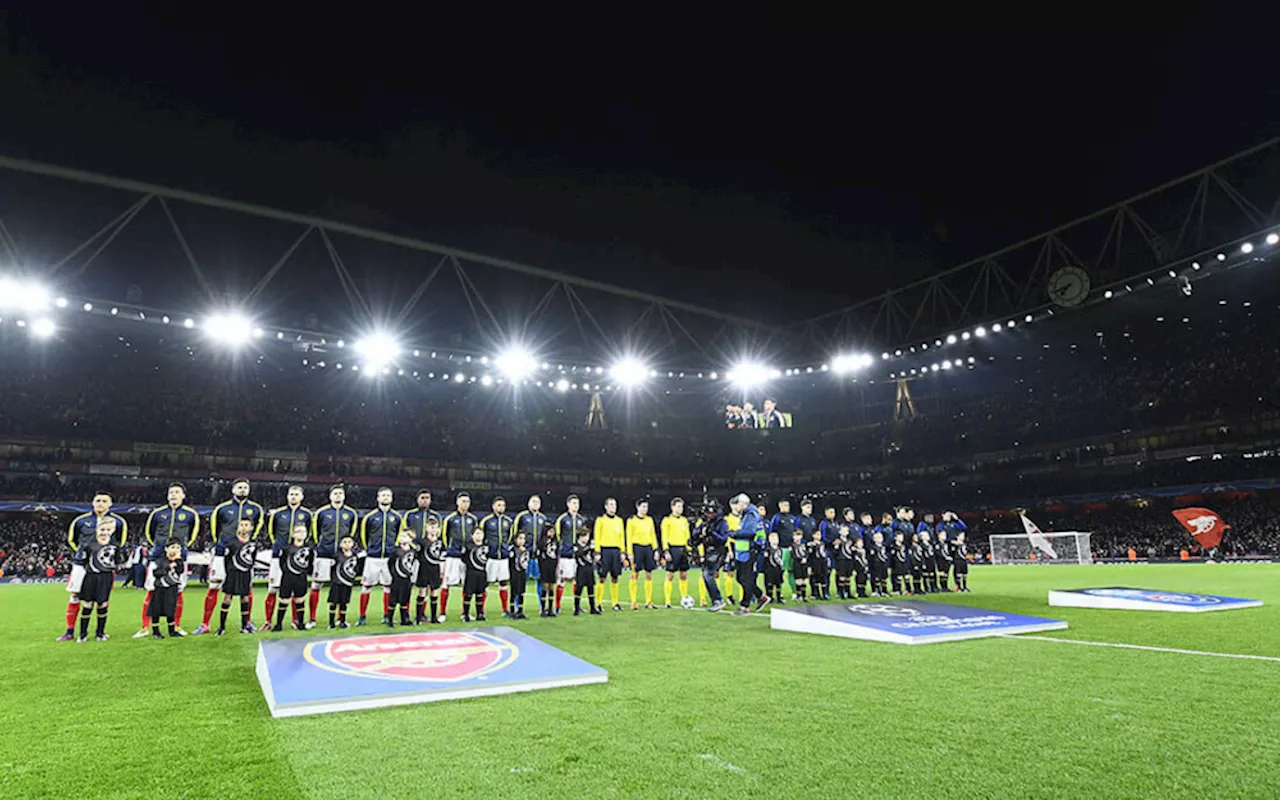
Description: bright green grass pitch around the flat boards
xmin=0 ymin=564 xmax=1280 ymax=800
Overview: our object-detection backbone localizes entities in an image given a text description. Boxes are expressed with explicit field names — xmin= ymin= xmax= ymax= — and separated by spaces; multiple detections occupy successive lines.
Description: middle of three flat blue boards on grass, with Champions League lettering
xmin=769 ymin=600 xmax=1066 ymax=644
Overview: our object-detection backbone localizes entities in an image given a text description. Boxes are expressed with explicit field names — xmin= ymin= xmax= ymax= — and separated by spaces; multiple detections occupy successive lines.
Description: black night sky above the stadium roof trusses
xmin=0 ymin=4 xmax=1280 ymax=321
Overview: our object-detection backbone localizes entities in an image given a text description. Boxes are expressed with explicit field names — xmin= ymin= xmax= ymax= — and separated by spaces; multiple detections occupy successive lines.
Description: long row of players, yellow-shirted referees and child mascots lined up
xmin=59 ymin=480 xmax=969 ymax=641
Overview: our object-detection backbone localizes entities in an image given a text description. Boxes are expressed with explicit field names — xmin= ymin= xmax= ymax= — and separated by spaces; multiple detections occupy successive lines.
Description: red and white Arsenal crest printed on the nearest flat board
xmin=305 ymin=631 xmax=520 ymax=684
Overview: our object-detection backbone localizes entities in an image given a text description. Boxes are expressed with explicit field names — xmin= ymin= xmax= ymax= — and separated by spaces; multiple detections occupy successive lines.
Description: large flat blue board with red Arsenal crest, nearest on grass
xmin=257 ymin=627 xmax=608 ymax=717
